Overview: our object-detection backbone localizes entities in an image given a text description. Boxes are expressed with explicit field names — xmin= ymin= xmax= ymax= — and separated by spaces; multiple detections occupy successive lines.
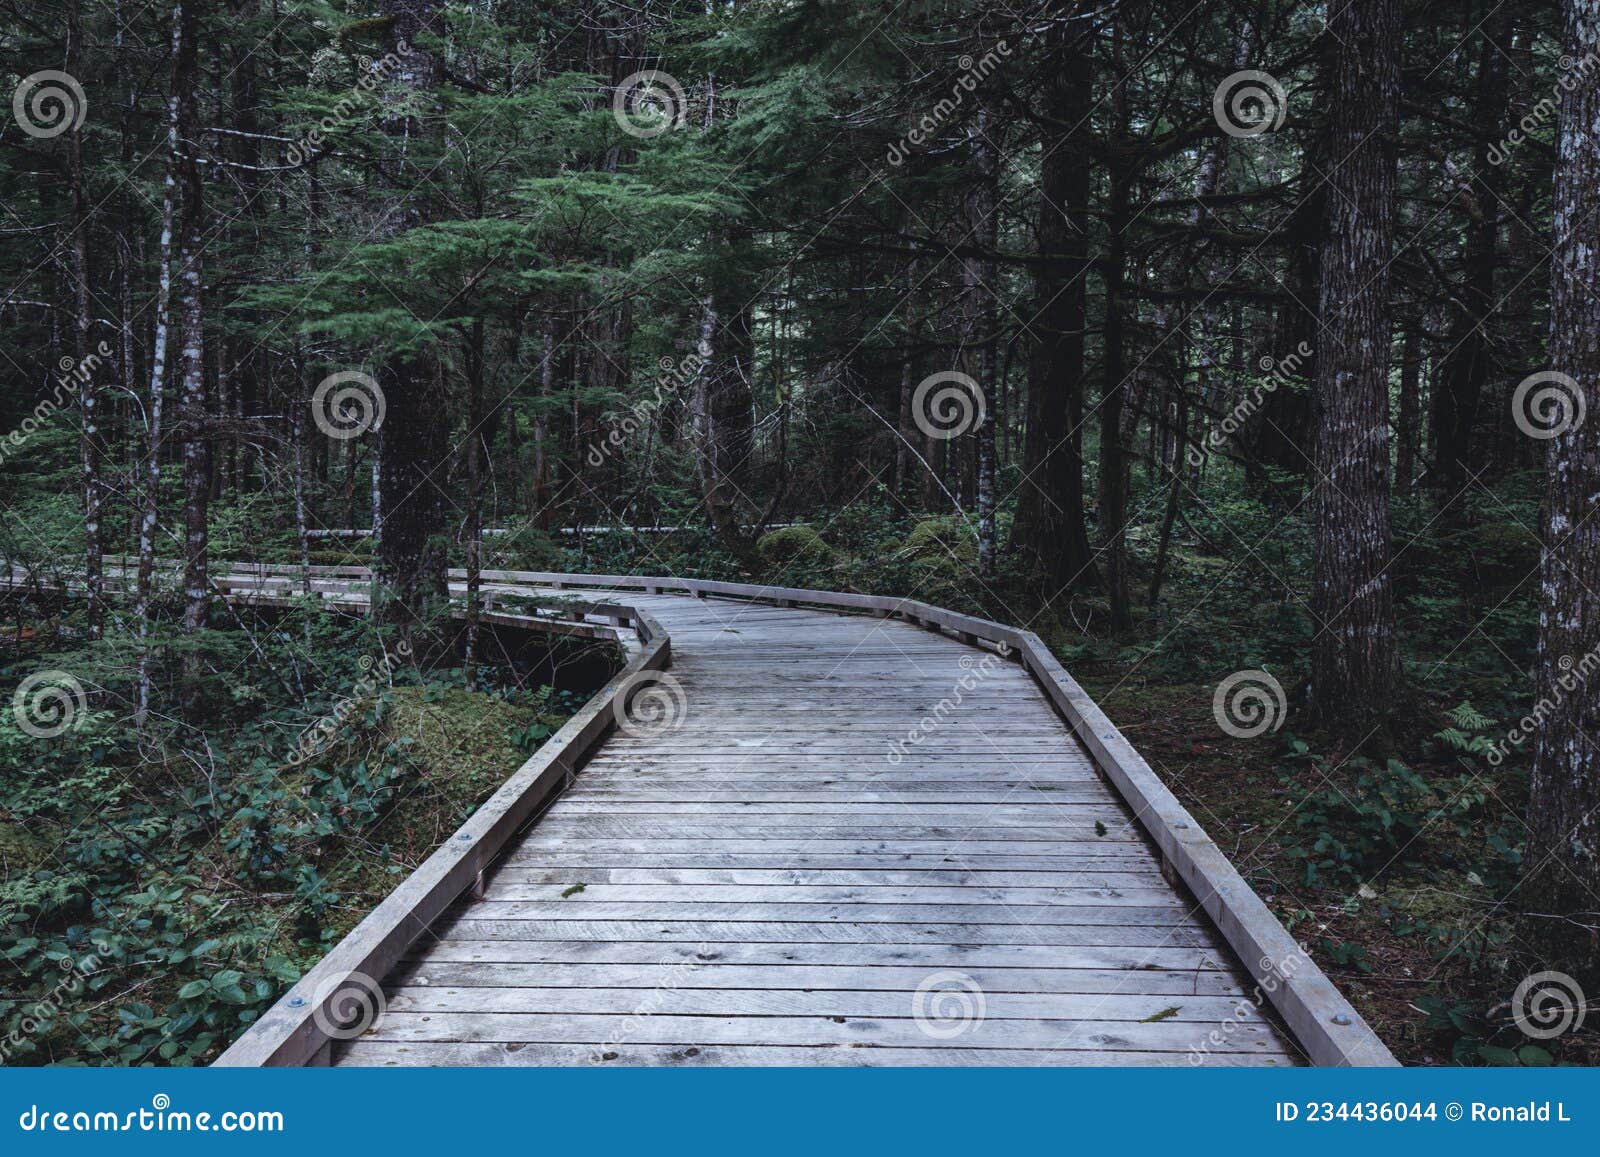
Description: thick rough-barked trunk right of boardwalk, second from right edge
xmin=1312 ymin=0 xmax=1400 ymax=733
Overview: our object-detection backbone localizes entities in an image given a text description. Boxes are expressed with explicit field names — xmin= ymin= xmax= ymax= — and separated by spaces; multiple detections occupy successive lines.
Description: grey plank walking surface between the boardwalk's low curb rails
xmin=331 ymin=592 xmax=1298 ymax=1066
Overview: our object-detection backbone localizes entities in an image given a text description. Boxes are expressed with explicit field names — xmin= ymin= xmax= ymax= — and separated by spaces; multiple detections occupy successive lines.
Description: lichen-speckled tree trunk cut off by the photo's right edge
xmin=1525 ymin=0 xmax=1600 ymax=1002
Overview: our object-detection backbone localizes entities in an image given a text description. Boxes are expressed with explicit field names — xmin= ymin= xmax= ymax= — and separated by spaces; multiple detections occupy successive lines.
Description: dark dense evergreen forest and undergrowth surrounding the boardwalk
xmin=0 ymin=0 xmax=1600 ymax=1064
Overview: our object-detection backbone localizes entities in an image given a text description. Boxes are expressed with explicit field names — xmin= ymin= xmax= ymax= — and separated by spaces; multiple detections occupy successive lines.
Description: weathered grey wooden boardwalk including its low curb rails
xmin=3 ymin=565 xmax=1395 ymax=1066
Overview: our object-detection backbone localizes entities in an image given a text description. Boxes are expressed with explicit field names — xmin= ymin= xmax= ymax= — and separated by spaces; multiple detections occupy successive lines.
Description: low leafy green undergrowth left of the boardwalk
xmin=0 ymin=621 xmax=571 ymax=1064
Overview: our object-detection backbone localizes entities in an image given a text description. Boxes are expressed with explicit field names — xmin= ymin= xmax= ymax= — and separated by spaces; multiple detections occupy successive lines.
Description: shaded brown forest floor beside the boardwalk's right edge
xmin=1074 ymin=678 xmax=1600 ymax=1066
